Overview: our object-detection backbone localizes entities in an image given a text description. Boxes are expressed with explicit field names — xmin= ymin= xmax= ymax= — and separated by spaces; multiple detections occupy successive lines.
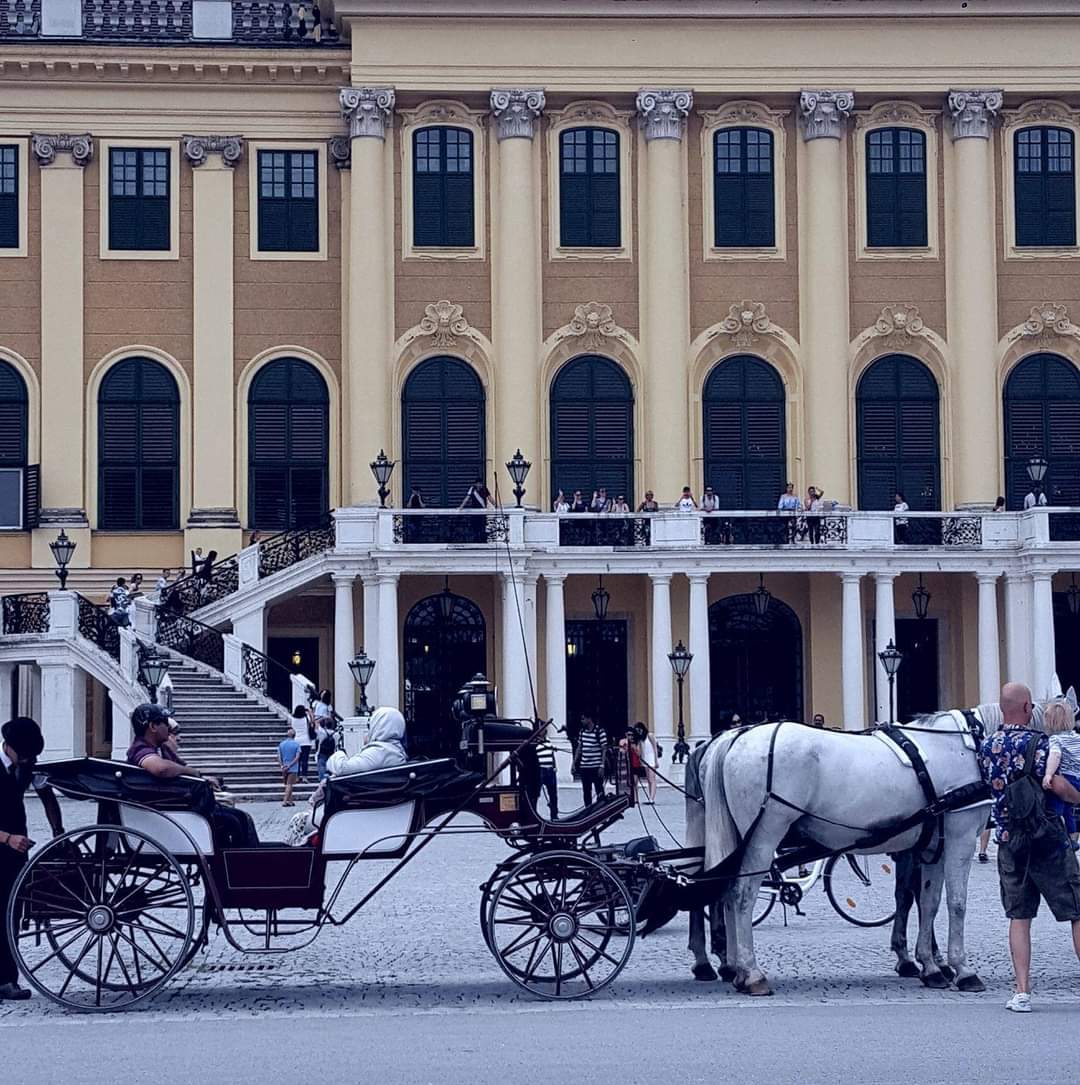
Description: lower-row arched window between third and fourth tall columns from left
xmin=701 ymin=355 xmax=787 ymax=509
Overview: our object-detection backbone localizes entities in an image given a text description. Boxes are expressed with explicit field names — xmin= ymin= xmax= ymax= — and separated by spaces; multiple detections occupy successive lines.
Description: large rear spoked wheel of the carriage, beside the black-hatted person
xmin=7 ymin=826 xmax=195 ymax=1012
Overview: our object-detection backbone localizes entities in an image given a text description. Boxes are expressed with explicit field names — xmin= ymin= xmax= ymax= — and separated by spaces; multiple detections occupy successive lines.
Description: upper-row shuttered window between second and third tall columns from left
xmin=559 ymin=128 xmax=622 ymax=248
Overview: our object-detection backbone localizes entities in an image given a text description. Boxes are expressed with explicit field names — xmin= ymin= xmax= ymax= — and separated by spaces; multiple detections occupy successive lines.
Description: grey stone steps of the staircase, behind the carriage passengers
xmin=168 ymin=653 xmax=315 ymax=802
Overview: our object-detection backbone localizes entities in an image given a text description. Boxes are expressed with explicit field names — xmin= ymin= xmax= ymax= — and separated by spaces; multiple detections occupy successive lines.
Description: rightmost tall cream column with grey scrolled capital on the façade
xmin=945 ymin=90 xmax=1002 ymax=508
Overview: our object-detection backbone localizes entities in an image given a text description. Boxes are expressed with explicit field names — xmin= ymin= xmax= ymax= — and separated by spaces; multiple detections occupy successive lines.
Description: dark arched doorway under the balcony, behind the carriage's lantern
xmin=403 ymin=590 xmax=487 ymax=757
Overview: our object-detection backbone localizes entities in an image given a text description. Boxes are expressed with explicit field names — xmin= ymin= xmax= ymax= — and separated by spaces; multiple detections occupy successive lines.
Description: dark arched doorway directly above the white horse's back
xmin=709 ymin=593 xmax=802 ymax=727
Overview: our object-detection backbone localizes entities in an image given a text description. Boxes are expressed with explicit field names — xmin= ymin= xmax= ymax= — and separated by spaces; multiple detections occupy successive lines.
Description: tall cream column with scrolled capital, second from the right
xmin=799 ymin=90 xmax=861 ymax=501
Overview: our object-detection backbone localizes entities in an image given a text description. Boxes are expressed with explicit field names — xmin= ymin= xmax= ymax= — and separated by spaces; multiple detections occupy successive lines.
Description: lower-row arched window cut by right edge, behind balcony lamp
xmin=1005 ymin=354 xmax=1080 ymax=509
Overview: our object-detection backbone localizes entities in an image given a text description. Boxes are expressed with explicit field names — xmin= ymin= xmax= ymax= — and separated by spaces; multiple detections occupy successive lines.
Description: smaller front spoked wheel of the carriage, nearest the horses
xmin=486 ymin=852 xmax=635 ymax=999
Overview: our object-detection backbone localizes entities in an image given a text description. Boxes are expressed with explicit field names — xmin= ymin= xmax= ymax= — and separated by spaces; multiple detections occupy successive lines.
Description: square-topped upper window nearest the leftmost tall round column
xmin=258 ymin=151 xmax=319 ymax=253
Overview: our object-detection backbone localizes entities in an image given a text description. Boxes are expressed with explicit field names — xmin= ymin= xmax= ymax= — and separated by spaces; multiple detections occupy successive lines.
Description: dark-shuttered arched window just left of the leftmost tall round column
xmin=247 ymin=358 xmax=330 ymax=531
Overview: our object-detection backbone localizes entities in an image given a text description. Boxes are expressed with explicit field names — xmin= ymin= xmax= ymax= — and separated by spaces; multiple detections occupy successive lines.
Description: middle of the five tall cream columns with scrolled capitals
xmin=637 ymin=90 xmax=694 ymax=496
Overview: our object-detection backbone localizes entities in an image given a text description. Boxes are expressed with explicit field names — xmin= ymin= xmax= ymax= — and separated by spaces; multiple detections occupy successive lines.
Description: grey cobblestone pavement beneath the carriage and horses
xmin=0 ymin=789 xmax=1080 ymax=1027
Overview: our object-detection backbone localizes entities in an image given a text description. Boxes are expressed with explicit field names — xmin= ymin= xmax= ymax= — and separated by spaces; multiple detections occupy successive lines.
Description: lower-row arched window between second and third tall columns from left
xmin=551 ymin=354 xmax=634 ymax=506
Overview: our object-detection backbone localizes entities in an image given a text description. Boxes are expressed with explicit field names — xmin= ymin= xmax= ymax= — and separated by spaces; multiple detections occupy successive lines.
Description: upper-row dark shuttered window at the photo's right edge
xmin=1013 ymin=127 xmax=1077 ymax=247
